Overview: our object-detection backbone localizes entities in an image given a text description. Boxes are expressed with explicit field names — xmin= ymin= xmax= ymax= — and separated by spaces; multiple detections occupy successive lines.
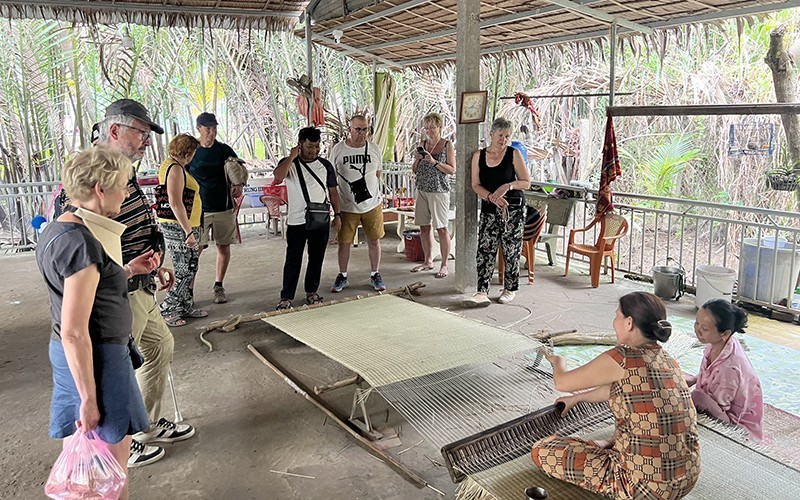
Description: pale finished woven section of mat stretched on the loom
xmin=264 ymin=295 xmax=542 ymax=387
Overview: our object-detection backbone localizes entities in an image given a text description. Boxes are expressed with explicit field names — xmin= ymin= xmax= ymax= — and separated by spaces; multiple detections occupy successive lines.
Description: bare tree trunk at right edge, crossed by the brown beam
xmin=764 ymin=24 xmax=800 ymax=204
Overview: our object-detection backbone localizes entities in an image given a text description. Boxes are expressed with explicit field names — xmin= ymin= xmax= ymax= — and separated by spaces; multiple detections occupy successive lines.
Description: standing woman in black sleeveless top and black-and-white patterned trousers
xmin=465 ymin=118 xmax=532 ymax=306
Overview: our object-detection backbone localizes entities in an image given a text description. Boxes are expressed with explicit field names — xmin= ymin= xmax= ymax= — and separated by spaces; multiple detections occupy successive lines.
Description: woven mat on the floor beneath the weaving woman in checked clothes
xmin=456 ymin=420 xmax=800 ymax=500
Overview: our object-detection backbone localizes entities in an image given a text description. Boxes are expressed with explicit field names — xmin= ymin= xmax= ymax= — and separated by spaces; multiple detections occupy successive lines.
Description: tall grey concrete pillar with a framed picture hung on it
xmin=455 ymin=0 xmax=481 ymax=292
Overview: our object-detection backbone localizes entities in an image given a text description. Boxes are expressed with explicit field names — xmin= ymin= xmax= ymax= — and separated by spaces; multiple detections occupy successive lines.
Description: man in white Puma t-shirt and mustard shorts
xmin=330 ymin=115 xmax=386 ymax=292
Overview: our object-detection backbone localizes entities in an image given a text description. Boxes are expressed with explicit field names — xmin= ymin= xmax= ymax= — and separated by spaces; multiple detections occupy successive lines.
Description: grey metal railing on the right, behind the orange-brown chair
xmin=533 ymin=182 xmax=800 ymax=314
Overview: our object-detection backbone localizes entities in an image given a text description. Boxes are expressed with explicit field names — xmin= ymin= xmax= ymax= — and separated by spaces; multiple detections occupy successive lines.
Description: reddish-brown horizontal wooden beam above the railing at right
xmin=608 ymin=102 xmax=800 ymax=116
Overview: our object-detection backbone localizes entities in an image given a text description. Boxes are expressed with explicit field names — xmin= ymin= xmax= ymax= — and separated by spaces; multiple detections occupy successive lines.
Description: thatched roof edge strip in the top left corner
xmin=0 ymin=0 xmax=308 ymax=30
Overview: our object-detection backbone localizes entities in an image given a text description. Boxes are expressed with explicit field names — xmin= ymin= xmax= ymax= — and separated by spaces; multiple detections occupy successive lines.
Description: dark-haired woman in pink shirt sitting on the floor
xmin=686 ymin=299 xmax=764 ymax=441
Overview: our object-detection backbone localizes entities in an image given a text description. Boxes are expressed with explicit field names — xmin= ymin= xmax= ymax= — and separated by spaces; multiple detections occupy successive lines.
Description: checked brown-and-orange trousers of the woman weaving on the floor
xmin=531 ymin=436 xmax=697 ymax=500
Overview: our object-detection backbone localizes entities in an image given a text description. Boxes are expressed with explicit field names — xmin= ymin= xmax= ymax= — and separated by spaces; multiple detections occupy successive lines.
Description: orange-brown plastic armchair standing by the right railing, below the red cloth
xmin=564 ymin=213 xmax=628 ymax=288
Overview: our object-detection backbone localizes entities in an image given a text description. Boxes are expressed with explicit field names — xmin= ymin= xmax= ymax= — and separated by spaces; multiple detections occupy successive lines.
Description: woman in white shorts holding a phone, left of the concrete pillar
xmin=411 ymin=113 xmax=456 ymax=278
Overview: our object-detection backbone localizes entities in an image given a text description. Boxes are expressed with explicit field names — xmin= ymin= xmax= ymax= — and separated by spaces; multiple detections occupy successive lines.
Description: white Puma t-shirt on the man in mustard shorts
xmin=330 ymin=141 xmax=383 ymax=214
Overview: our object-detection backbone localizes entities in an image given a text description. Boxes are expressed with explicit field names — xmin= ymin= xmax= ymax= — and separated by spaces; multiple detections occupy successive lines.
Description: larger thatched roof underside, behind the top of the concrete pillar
xmin=310 ymin=0 xmax=800 ymax=67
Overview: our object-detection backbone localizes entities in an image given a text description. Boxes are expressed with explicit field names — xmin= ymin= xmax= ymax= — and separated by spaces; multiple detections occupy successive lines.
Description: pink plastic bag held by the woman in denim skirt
xmin=44 ymin=430 xmax=125 ymax=500
